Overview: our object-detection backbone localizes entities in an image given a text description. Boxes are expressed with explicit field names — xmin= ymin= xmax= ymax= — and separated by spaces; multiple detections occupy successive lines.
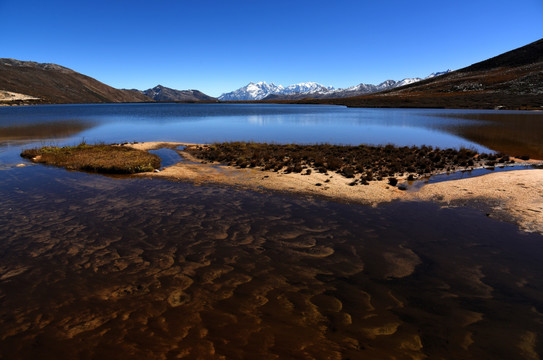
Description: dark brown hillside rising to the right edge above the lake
xmin=299 ymin=39 xmax=543 ymax=109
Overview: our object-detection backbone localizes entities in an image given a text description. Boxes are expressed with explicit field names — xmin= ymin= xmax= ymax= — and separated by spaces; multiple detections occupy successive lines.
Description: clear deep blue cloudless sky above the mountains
xmin=0 ymin=0 xmax=543 ymax=96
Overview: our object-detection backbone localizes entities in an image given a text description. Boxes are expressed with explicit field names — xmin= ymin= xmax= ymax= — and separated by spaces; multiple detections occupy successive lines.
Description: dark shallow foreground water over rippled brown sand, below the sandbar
xmin=0 ymin=169 xmax=543 ymax=359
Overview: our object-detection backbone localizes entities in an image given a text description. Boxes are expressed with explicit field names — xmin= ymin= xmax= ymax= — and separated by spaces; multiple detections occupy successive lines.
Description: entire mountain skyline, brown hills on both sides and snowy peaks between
xmin=0 ymin=39 xmax=543 ymax=109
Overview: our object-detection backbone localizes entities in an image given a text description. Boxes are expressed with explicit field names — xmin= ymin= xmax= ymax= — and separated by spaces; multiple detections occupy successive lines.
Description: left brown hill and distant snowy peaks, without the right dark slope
xmin=0 ymin=59 xmax=442 ymax=104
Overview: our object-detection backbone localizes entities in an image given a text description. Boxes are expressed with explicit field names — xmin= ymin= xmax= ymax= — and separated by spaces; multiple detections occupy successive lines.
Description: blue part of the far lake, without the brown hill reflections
xmin=0 ymin=104 xmax=516 ymax=151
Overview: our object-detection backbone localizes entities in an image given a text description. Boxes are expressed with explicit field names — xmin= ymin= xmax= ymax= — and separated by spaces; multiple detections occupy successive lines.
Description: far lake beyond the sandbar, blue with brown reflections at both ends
xmin=0 ymin=104 xmax=543 ymax=158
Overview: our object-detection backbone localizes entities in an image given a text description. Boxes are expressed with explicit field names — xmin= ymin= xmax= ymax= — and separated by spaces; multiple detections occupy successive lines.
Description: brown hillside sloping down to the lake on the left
xmin=0 ymin=59 xmax=152 ymax=104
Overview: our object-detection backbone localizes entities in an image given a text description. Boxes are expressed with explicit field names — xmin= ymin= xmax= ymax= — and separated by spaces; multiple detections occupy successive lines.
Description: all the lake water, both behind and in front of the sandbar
xmin=0 ymin=104 xmax=543 ymax=359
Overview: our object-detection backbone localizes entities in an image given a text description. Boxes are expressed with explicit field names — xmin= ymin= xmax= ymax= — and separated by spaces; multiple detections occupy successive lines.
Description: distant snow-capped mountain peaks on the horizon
xmin=219 ymin=70 xmax=450 ymax=101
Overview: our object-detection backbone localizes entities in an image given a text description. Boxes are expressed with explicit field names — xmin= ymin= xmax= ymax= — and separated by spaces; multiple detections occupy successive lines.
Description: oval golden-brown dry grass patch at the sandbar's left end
xmin=21 ymin=143 xmax=160 ymax=174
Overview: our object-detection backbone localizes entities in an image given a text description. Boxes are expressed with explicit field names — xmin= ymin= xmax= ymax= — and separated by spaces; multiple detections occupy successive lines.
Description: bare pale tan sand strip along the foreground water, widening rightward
xmin=128 ymin=142 xmax=543 ymax=234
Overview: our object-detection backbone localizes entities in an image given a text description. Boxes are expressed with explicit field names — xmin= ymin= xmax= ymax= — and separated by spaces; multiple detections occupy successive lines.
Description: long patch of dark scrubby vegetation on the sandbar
xmin=186 ymin=142 xmax=511 ymax=185
